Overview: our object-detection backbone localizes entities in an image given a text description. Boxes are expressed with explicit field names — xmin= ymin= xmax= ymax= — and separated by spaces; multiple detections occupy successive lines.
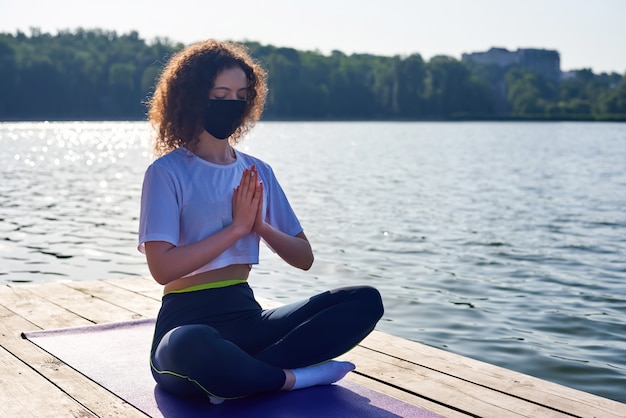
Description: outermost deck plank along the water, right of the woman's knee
xmin=361 ymin=331 xmax=626 ymax=418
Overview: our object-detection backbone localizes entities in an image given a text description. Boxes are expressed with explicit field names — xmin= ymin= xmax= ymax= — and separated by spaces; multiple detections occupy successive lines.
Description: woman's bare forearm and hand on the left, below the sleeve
xmin=145 ymin=167 xmax=263 ymax=285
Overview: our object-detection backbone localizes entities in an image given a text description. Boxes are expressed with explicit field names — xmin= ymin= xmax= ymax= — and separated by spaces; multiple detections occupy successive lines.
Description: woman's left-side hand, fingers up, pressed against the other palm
xmin=233 ymin=166 xmax=263 ymax=236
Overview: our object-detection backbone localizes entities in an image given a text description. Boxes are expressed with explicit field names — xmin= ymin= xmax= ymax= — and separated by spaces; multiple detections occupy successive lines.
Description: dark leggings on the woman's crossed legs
xmin=151 ymin=283 xmax=383 ymax=398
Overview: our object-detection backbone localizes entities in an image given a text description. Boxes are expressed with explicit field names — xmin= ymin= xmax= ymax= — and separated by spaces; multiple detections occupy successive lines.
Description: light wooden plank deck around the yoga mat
xmin=0 ymin=278 xmax=626 ymax=418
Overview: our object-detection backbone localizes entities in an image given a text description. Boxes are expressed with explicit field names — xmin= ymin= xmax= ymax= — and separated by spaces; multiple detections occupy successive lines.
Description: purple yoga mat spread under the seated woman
xmin=22 ymin=319 xmax=439 ymax=418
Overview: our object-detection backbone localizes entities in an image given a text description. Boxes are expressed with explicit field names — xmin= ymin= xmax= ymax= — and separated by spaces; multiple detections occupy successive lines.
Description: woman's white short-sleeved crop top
xmin=138 ymin=148 xmax=302 ymax=276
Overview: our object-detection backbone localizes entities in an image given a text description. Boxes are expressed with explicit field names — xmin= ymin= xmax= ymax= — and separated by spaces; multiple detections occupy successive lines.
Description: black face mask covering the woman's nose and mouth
xmin=202 ymin=99 xmax=246 ymax=139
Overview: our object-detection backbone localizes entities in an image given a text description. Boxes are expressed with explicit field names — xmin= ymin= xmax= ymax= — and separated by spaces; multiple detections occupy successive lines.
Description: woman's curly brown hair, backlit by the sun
xmin=148 ymin=39 xmax=267 ymax=156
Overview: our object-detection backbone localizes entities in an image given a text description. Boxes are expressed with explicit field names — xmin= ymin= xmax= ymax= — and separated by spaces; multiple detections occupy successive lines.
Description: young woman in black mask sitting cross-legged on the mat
xmin=139 ymin=40 xmax=383 ymax=403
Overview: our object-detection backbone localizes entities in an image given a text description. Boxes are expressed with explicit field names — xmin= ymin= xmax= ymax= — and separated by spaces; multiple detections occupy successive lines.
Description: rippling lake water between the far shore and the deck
xmin=0 ymin=122 xmax=626 ymax=402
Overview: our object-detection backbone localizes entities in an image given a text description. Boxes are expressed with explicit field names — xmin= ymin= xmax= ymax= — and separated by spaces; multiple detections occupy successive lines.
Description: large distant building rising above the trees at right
xmin=461 ymin=48 xmax=561 ymax=82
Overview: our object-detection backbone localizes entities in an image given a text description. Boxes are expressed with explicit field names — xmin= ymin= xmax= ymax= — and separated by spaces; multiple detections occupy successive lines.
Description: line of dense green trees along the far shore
xmin=0 ymin=29 xmax=626 ymax=120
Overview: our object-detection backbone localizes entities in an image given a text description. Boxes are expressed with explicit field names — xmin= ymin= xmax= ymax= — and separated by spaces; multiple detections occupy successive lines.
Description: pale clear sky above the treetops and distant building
xmin=0 ymin=0 xmax=626 ymax=74
